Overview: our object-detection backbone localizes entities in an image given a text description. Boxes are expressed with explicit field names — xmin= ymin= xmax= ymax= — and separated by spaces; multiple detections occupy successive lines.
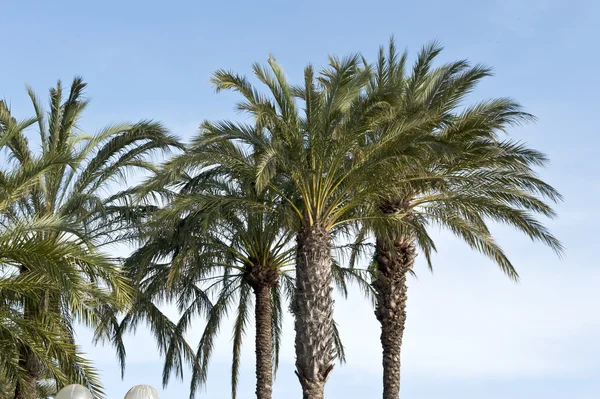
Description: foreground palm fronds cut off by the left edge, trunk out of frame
xmin=0 ymin=102 xmax=103 ymax=397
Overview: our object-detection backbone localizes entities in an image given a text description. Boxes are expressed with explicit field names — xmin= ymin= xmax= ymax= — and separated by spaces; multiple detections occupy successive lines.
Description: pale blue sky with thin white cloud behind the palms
xmin=0 ymin=0 xmax=600 ymax=399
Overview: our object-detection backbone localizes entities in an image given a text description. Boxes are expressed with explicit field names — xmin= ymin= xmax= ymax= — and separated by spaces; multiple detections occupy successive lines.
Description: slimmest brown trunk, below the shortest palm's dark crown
xmin=254 ymin=284 xmax=273 ymax=399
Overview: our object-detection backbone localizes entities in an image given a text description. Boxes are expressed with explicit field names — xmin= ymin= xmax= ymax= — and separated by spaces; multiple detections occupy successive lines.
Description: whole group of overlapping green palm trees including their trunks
xmin=0 ymin=40 xmax=562 ymax=399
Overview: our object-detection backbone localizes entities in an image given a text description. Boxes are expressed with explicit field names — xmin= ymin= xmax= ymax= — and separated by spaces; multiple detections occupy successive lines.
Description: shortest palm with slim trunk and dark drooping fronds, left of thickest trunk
xmin=128 ymin=162 xmax=293 ymax=399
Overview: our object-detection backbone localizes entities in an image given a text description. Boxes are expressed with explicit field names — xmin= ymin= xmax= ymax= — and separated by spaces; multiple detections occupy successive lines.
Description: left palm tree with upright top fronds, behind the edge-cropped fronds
xmin=0 ymin=78 xmax=178 ymax=398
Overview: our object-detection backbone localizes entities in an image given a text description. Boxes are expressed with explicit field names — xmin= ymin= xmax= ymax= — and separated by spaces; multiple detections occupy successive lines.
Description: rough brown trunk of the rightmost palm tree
xmin=373 ymin=238 xmax=416 ymax=399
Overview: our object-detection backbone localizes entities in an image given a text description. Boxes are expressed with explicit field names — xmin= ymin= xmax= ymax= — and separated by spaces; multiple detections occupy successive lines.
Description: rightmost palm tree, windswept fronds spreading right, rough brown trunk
xmin=358 ymin=40 xmax=562 ymax=399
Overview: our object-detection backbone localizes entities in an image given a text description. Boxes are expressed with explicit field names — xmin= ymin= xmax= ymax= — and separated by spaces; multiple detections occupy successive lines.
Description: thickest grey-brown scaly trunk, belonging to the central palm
xmin=294 ymin=225 xmax=335 ymax=399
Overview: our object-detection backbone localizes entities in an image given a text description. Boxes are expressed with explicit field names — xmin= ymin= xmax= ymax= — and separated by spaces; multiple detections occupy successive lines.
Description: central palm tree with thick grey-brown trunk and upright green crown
xmin=185 ymin=56 xmax=428 ymax=399
